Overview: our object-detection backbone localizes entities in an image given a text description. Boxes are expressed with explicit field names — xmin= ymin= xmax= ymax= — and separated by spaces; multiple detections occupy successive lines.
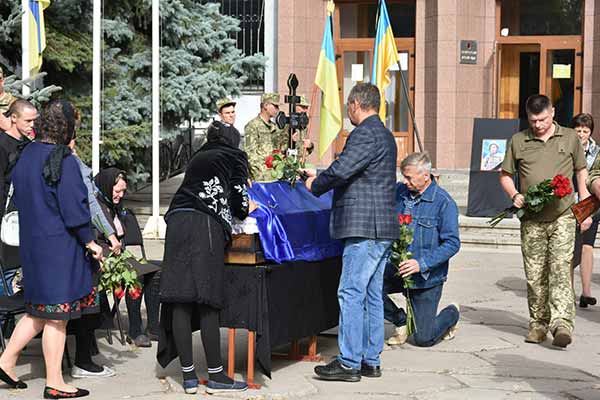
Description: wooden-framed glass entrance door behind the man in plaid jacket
xmin=335 ymin=38 xmax=414 ymax=164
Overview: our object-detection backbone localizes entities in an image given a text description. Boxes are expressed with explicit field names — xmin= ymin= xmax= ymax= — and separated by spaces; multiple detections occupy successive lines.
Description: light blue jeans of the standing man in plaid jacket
xmin=338 ymin=238 xmax=392 ymax=369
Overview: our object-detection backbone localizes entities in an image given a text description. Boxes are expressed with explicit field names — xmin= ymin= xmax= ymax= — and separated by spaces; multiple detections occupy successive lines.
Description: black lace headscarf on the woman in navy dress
xmin=39 ymin=100 xmax=76 ymax=186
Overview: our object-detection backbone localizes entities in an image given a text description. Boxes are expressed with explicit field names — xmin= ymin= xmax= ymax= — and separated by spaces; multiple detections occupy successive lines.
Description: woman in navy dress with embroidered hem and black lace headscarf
xmin=0 ymin=100 xmax=102 ymax=399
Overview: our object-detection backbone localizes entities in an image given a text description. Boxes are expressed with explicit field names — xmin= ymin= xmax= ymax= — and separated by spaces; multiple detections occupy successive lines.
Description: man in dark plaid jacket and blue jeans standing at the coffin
xmin=306 ymin=83 xmax=399 ymax=382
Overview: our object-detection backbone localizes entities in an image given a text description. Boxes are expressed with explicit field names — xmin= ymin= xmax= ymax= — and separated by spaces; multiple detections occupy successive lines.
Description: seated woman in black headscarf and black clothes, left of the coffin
xmin=94 ymin=168 xmax=160 ymax=347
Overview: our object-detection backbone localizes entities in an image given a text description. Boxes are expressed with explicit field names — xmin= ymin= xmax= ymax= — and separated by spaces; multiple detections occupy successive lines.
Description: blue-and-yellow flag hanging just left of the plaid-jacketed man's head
xmin=315 ymin=0 xmax=342 ymax=158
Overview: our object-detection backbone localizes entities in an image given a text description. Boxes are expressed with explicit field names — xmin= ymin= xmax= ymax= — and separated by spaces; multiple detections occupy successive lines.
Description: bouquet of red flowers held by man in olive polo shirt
xmin=488 ymin=175 xmax=573 ymax=227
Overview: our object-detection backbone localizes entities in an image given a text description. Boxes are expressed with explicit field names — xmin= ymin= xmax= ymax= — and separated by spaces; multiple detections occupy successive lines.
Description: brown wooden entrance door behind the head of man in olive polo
xmin=498 ymin=36 xmax=582 ymax=126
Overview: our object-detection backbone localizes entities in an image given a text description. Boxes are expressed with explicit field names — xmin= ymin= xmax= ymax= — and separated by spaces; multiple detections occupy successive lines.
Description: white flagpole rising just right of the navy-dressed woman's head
xmin=92 ymin=0 xmax=102 ymax=175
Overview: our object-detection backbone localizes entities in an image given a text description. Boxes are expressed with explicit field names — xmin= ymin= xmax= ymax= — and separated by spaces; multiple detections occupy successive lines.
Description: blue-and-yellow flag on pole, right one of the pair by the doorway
xmin=371 ymin=0 xmax=398 ymax=123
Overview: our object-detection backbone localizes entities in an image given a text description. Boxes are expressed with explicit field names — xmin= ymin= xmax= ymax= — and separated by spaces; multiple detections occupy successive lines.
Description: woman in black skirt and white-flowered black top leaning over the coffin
xmin=157 ymin=119 xmax=256 ymax=394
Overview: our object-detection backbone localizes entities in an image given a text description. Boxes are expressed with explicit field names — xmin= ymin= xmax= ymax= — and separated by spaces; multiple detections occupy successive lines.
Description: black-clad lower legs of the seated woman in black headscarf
xmin=125 ymin=271 xmax=160 ymax=339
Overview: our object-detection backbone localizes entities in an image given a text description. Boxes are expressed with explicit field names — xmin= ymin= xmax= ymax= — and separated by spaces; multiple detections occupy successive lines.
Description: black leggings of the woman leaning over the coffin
xmin=172 ymin=303 xmax=223 ymax=368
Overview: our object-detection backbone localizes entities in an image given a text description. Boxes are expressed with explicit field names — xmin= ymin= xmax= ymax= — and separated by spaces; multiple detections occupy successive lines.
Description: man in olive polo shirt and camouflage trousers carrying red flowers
xmin=500 ymin=95 xmax=591 ymax=348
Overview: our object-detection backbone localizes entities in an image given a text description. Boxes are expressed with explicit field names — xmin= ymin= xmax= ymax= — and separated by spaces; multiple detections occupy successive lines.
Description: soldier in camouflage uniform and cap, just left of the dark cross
xmin=244 ymin=93 xmax=288 ymax=181
